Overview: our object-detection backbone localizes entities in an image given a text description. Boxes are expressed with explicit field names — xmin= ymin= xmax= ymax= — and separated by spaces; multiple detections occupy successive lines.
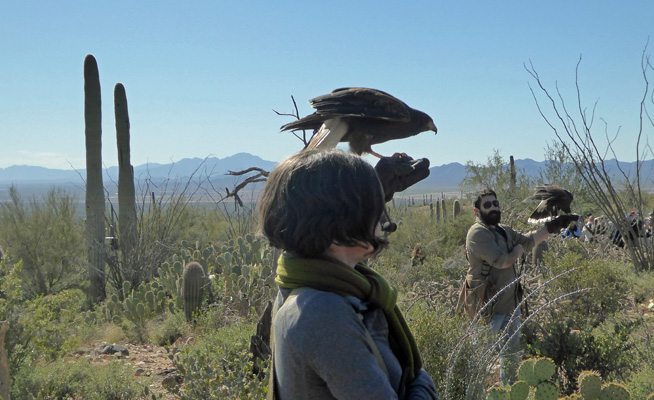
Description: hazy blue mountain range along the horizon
xmin=0 ymin=153 xmax=654 ymax=200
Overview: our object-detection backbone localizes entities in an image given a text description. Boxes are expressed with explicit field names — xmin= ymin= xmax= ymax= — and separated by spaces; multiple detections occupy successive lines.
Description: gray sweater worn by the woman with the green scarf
xmin=273 ymin=288 xmax=438 ymax=400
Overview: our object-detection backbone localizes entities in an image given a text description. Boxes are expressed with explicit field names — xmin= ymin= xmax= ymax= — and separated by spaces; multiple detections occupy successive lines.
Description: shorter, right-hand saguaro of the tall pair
xmin=114 ymin=83 xmax=137 ymax=270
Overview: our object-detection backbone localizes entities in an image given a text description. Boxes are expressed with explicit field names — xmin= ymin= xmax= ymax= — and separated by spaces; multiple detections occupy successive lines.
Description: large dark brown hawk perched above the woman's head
xmin=281 ymin=88 xmax=437 ymax=158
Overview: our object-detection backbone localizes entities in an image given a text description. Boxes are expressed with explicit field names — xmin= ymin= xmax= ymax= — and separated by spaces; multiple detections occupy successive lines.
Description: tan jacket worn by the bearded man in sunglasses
xmin=466 ymin=219 xmax=535 ymax=314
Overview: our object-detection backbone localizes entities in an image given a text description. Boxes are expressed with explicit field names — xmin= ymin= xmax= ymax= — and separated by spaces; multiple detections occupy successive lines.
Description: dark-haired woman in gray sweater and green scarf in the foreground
xmin=259 ymin=150 xmax=438 ymax=400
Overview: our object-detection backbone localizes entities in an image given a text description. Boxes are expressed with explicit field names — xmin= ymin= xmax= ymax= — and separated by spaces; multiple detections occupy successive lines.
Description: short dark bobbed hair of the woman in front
xmin=259 ymin=150 xmax=387 ymax=258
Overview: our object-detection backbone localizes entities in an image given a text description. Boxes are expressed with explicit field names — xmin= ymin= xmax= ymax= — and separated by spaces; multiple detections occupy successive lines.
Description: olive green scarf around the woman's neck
xmin=275 ymin=255 xmax=422 ymax=383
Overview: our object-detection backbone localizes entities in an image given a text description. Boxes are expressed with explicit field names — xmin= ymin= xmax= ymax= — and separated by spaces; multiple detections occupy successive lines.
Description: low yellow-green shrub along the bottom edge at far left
xmin=11 ymin=360 xmax=147 ymax=400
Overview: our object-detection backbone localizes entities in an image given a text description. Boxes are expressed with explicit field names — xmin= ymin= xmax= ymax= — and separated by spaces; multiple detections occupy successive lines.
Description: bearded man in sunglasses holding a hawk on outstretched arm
xmin=466 ymin=189 xmax=578 ymax=384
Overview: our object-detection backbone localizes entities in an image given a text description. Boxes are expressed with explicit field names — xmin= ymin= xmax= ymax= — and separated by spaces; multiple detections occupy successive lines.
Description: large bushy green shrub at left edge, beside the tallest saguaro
xmin=0 ymin=186 xmax=86 ymax=297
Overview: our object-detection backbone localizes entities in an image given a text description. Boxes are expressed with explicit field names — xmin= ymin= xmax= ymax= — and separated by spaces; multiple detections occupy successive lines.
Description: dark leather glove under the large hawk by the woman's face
xmin=375 ymin=153 xmax=429 ymax=202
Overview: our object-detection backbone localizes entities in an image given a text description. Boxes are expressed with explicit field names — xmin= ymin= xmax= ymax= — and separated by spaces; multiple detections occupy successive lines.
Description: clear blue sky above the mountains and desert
xmin=0 ymin=0 xmax=654 ymax=169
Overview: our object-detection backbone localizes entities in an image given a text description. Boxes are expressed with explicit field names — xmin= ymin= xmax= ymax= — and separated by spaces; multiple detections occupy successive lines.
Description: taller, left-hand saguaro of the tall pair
xmin=84 ymin=54 xmax=107 ymax=304
